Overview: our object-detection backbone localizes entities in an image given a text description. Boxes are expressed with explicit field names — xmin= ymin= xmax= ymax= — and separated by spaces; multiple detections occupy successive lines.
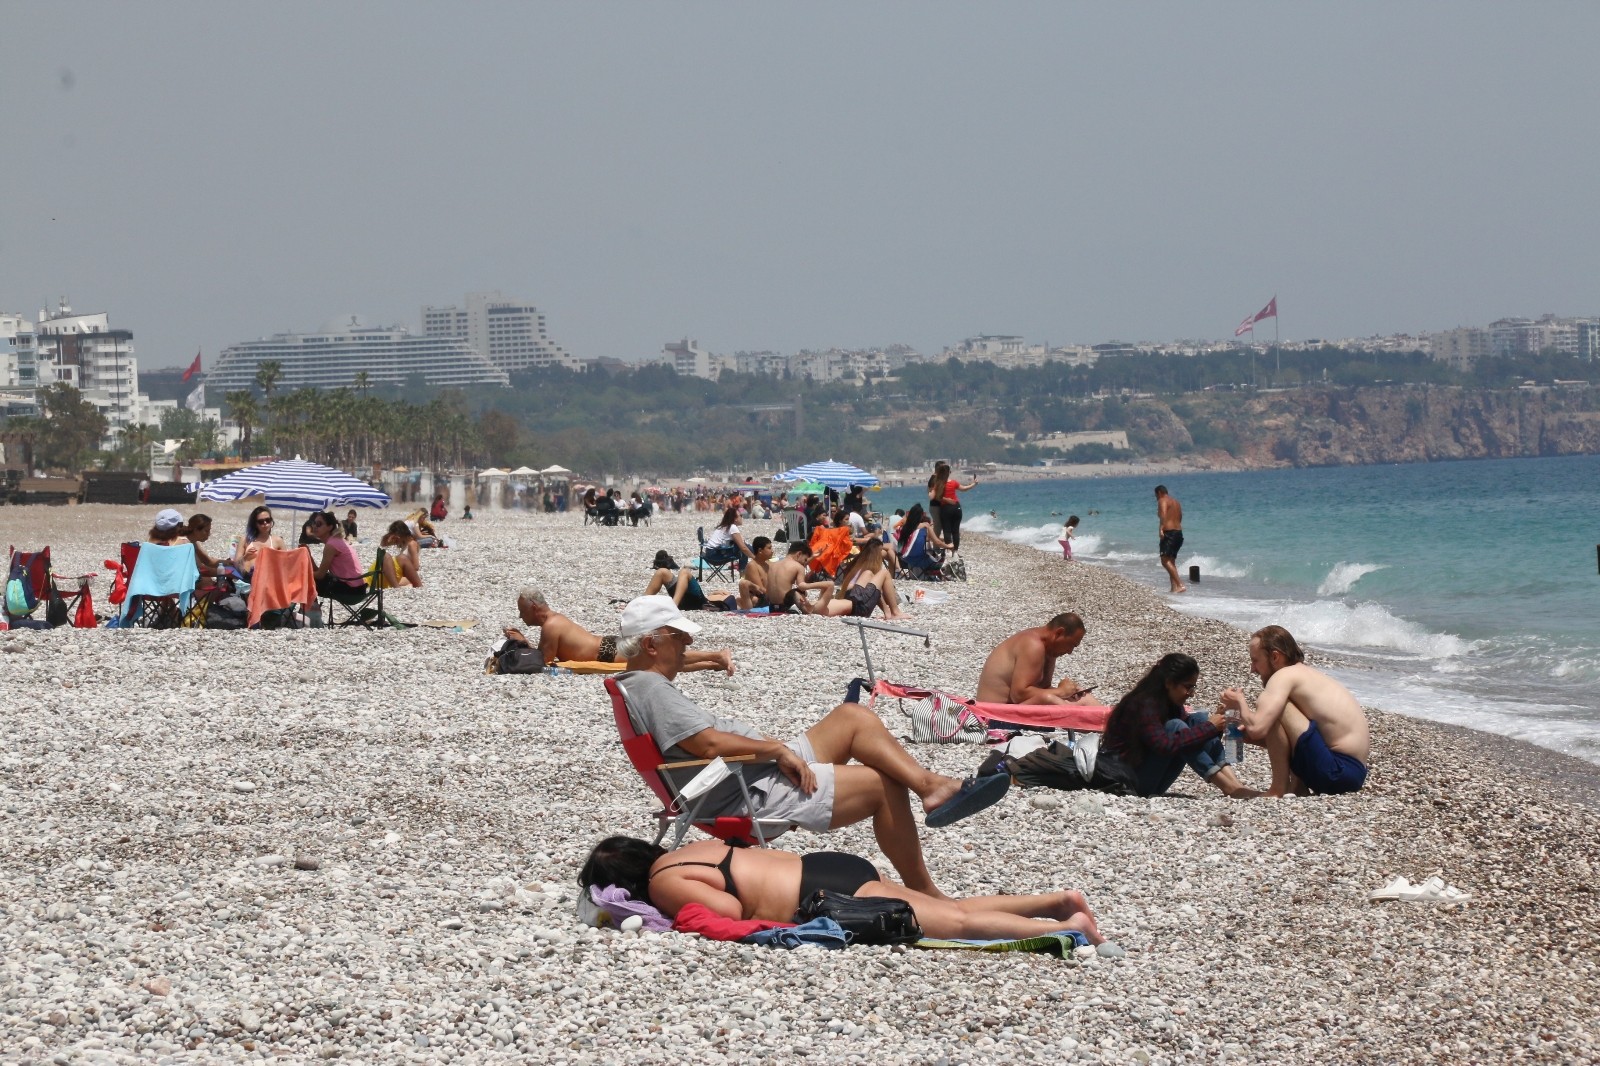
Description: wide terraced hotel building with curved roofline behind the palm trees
xmin=206 ymin=315 xmax=510 ymax=397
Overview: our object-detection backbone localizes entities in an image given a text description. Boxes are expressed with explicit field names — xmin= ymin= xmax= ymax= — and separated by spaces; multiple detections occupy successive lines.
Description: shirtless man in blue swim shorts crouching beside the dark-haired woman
xmin=1222 ymin=626 xmax=1371 ymax=795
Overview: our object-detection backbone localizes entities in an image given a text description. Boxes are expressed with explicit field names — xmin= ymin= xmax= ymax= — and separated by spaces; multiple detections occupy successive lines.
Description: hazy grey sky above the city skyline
xmin=0 ymin=0 xmax=1600 ymax=368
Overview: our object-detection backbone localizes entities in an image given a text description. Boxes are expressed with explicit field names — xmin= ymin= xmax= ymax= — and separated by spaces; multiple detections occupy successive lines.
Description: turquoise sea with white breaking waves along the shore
xmin=874 ymin=456 xmax=1600 ymax=763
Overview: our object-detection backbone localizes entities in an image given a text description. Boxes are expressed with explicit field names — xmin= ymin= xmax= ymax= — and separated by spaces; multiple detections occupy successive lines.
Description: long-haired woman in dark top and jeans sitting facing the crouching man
xmin=1096 ymin=651 xmax=1259 ymax=799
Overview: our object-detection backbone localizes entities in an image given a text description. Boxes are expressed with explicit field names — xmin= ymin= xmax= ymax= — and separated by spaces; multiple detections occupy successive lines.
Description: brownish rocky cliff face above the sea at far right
xmin=1189 ymin=386 xmax=1600 ymax=467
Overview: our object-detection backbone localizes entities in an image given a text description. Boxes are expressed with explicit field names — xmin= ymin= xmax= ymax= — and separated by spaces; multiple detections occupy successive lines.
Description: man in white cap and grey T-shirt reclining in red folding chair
xmin=616 ymin=595 xmax=1011 ymax=898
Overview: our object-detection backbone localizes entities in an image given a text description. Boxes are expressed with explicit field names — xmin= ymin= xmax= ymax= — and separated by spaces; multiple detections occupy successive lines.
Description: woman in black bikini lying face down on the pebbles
xmin=578 ymin=837 xmax=1104 ymax=944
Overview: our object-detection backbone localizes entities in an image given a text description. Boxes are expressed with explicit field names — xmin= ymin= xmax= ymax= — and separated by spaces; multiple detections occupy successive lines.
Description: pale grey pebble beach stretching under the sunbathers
xmin=0 ymin=506 xmax=1600 ymax=1064
